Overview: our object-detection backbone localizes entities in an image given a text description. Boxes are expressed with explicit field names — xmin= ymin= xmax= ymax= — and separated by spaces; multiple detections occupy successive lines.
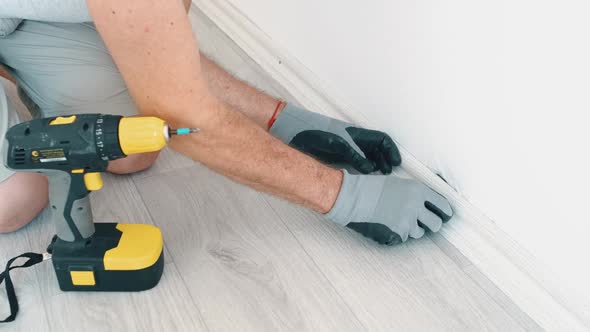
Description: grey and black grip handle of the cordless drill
xmin=42 ymin=170 xmax=94 ymax=242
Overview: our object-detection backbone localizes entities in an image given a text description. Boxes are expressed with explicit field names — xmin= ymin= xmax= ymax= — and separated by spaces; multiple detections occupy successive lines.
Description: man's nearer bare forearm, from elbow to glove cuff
xmin=171 ymin=98 xmax=342 ymax=213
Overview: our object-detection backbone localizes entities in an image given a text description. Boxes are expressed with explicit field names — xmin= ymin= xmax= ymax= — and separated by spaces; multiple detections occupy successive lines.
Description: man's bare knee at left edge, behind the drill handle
xmin=0 ymin=173 xmax=47 ymax=233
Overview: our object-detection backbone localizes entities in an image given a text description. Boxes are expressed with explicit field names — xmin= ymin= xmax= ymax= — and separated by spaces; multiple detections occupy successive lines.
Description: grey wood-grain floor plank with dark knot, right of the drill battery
xmin=134 ymin=165 xmax=363 ymax=331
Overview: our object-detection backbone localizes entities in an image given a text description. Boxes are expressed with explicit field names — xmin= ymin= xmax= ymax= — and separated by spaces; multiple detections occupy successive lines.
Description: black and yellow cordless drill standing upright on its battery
xmin=5 ymin=114 xmax=196 ymax=291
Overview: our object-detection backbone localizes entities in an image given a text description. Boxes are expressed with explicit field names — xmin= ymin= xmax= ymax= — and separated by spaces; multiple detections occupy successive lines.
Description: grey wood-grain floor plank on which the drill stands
xmin=19 ymin=174 xmax=206 ymax=331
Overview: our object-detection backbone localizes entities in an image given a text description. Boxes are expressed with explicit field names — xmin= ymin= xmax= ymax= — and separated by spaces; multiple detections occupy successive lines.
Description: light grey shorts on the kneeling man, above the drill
xmin=0 ymin=21 xmax=137 ymax=182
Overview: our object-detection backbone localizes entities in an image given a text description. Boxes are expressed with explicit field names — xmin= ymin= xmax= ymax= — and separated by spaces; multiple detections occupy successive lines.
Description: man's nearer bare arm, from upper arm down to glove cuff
xmin=88 ymin=0 xmax=342 ymax=213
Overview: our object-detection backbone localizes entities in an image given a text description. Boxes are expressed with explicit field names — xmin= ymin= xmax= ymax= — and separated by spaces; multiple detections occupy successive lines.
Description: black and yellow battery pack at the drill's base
xmin=48 ymin=223 xmax=164 ymax=292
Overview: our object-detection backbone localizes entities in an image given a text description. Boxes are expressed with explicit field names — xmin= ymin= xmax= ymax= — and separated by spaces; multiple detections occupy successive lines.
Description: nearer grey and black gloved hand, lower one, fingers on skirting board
xmin=326 ymin=170 xmax=453 ymax=245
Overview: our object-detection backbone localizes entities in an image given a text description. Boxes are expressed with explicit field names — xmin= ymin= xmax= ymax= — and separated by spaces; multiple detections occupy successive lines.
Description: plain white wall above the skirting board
xmin=230 ymin=0 xmax=590 ymax=293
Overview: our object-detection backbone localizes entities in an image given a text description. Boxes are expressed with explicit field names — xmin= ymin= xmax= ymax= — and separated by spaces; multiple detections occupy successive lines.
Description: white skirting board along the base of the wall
xmin=193 ymin=0 xmax=590 ymax=331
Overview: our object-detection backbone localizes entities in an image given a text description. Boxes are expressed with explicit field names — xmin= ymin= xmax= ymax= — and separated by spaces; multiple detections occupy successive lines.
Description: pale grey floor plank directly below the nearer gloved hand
xmin=265 ymin=196 xmax=523 ymax=331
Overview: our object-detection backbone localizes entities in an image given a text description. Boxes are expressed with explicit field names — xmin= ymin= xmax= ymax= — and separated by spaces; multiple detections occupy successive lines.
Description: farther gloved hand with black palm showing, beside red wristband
xmin=270 ymin=104 xmax=401 ymax=174
